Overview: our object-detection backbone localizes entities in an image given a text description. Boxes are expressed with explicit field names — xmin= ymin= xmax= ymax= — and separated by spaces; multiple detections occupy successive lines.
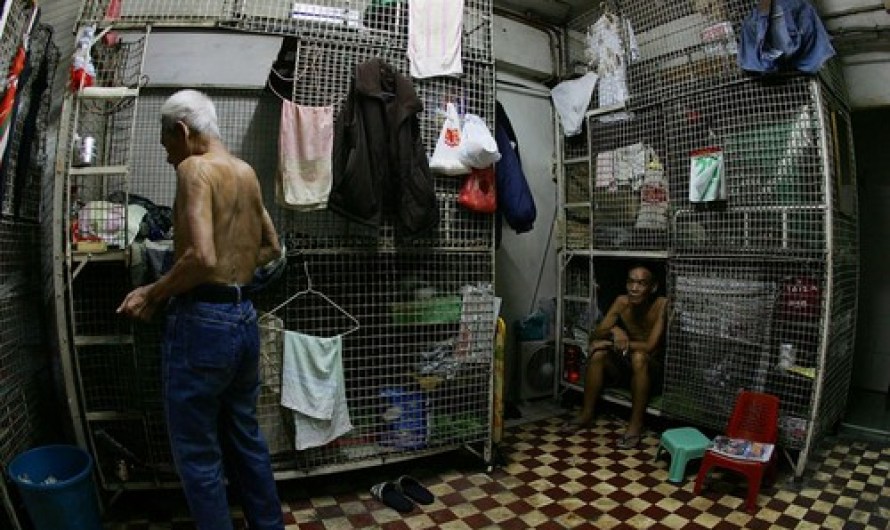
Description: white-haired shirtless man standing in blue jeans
xmin=118 ymin=90 xmax=284 ymax=530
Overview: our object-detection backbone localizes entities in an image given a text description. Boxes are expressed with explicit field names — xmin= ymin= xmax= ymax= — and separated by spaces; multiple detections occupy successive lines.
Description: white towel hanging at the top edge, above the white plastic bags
xmin=408 ymin=0 xmax=464 ymax=79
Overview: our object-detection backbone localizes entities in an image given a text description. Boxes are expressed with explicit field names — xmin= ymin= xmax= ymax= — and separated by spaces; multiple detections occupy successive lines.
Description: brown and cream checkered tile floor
xmin=106 ymin=414 xmax=890 ymax=530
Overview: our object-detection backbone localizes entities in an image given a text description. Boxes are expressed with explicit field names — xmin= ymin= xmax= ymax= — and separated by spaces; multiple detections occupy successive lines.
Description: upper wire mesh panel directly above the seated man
xmin=588 ymin=107 xmax=670 ymax=250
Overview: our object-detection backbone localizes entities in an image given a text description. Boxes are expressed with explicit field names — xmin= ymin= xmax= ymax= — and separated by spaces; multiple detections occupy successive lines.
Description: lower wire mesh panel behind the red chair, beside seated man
xmin=663 ymin=259 xmax=825 ymax=448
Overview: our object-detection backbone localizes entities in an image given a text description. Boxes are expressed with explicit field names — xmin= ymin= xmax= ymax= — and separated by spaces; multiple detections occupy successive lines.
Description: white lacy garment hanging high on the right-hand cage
xmin=585 ymin=13 xmax=640 ymax=121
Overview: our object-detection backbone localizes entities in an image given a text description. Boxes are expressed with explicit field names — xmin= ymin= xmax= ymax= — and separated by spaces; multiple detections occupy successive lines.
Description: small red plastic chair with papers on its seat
xmin=695 ymin=391 xmax=779 ymax=513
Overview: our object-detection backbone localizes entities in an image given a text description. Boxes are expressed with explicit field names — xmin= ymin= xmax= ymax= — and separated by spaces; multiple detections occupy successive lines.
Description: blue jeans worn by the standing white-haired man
xmin=162 ymin=298 xmax=284 ymax=530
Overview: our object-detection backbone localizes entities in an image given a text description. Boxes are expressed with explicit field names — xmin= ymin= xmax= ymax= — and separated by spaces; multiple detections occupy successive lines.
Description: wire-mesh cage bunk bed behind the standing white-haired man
xmin=55 ymin=0 xmax=495 ymax=489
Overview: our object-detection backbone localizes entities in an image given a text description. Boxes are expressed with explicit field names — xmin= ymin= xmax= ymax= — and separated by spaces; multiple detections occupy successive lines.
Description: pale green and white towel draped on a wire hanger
xmin=281 ymin=331 xmax=352 ymax=450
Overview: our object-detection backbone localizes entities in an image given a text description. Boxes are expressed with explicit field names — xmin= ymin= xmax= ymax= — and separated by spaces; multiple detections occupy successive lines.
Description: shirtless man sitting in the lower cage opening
xmin=562 ymin=264 xmax=667 ymax=449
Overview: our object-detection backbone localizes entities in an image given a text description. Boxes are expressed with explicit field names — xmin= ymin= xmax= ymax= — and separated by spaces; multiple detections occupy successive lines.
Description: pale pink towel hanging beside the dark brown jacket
xmin=275 ymin=101 xmax=334 ymax=211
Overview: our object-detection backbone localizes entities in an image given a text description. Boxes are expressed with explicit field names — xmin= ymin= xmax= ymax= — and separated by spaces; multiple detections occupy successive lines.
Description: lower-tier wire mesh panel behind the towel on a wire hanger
xmin=258 ymin=252 xmax=494 ymax=468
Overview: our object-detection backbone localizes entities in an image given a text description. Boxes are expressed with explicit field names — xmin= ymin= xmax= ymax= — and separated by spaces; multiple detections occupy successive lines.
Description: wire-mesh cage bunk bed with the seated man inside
xmin=559 ymin=1 xmax=859 ymax=477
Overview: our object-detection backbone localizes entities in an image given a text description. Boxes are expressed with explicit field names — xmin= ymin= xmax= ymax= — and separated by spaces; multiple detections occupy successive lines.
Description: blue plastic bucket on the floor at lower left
xmin=6 ymin=445 xmax=102 ymax=530
